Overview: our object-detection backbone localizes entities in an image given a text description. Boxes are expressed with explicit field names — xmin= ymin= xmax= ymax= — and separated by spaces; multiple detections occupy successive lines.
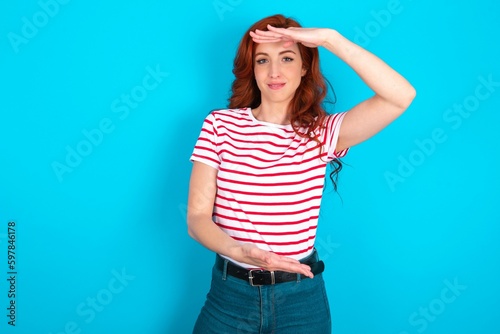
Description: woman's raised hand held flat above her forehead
xmin=250 ymin=25 xmax=331 ymax=48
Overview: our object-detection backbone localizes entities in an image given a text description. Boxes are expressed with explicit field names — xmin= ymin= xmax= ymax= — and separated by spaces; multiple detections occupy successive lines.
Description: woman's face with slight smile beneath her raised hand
xmin=254 ymin=42 xmax=306 ymax=103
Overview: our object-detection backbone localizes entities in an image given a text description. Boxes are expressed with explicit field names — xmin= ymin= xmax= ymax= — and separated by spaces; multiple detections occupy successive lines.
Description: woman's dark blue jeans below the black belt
xmin=193 ymin=252 xmax=331 ymax=334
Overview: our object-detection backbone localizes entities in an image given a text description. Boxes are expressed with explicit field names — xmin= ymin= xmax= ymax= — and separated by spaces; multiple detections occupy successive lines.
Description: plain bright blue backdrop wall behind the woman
xmin=0 ymin=0 xmax=500 ymax=334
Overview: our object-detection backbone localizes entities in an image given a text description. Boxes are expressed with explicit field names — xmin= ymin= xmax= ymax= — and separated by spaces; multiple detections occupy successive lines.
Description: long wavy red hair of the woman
xmin=229 ymin=14 xmax=326 ymax=137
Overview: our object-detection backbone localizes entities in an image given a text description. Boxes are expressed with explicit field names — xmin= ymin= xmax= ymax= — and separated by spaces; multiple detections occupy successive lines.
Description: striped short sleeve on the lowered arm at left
xmin=189 ymin=113 xmax=220 ymax=169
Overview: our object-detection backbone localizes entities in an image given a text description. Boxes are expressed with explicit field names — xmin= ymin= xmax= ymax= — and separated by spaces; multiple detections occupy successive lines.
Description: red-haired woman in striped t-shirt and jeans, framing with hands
xmin=187 ymin=15 xmax=415 ymax=334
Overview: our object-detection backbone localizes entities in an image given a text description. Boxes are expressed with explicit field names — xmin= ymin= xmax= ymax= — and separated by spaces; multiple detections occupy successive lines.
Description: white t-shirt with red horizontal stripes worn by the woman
xmin=191 ymin=108 xmax=348 ymax=268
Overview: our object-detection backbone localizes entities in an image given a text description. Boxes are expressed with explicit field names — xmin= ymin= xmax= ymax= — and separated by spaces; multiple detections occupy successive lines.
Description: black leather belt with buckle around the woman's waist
xmin=215 ymin=254 xmax=325 ymax=286
